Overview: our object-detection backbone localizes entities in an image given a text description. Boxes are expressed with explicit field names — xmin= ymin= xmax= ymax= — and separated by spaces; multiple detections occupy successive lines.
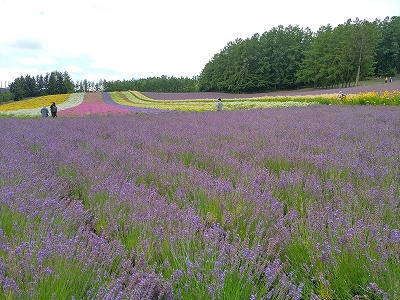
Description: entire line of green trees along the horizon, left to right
xmin=0 ymin=16 xmax=400 ymax=101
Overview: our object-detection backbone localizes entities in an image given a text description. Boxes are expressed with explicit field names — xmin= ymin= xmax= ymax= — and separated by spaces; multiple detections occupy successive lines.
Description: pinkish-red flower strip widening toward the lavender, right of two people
xmin=58 ymin=92 xmax=131 ymax=116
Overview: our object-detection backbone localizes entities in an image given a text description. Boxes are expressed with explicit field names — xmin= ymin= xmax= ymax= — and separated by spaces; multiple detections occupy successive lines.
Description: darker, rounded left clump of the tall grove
xmin=199 ymin=26 xmax=312 ymax=93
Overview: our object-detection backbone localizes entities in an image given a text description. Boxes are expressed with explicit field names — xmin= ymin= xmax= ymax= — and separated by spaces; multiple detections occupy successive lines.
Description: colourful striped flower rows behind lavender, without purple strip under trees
xmin=0 ymin=90 xmax=400 ymax=117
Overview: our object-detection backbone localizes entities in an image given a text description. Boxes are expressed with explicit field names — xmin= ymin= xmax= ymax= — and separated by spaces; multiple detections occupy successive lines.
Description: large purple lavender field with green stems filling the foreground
xmin=0 ymin=105 xmax=400 ymax=300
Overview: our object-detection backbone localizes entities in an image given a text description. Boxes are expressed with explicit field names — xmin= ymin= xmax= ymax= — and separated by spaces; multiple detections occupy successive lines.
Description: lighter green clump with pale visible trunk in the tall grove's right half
xmin=296 ymin=19 xmax=380 ymax=87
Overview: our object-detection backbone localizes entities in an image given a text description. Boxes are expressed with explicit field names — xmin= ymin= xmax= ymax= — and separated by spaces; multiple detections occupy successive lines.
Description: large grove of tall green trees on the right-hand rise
xmin=199 ymin=17 xmax=400 ymax=93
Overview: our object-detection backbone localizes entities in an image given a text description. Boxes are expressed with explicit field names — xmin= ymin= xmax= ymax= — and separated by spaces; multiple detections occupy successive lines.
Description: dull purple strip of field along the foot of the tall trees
xmin=143 ymin=79 xmax=400 ymax=100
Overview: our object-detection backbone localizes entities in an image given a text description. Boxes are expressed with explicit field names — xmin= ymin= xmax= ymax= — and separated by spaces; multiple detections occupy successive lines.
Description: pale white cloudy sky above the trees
xmin=0 ymin=0 xmax=400 ymax=87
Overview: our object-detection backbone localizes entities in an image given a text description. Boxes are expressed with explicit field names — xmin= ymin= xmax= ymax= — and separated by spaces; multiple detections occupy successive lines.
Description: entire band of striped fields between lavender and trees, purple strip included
xmin=0 ymin=81 xmax=400 ymax=118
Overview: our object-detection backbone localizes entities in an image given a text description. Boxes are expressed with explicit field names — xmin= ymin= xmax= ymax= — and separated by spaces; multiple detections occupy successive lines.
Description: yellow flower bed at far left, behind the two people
xmin=0 ymin=94 xmax=71 ymax=111
